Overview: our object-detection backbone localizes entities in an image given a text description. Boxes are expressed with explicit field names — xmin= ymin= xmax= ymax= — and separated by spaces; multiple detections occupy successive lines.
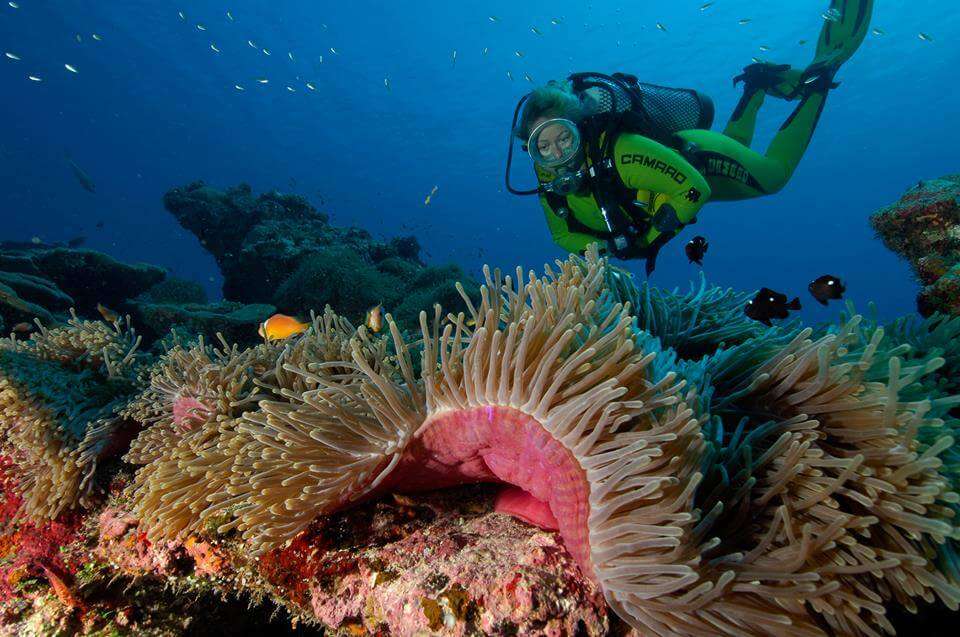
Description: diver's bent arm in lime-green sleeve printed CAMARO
xmin=614 ymin=133 xmax=710 ymax=245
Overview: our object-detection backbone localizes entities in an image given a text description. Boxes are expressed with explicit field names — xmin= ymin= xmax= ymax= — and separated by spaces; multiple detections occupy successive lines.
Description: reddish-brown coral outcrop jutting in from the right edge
xmin=870 ymin=175 xmax=960 ymax=316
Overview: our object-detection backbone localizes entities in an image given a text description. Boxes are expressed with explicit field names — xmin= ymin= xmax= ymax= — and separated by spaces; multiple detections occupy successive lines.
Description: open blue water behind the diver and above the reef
xmin=0 ymin=0 xmax=960 ymax=321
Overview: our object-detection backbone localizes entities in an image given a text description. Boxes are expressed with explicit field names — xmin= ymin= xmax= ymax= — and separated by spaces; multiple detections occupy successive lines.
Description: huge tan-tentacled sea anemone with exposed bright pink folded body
xmin=122 ymin=249 xmax=960 ymax=636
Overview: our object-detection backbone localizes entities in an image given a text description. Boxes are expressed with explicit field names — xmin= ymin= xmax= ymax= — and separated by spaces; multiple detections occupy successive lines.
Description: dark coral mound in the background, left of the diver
xmin=164 ymin=182 xmax=484 ymax=329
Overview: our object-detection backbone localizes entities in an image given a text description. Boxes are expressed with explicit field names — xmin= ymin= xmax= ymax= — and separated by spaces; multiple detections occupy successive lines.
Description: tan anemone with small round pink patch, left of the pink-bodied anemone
xmin=125 ymin=337 xmax=279 ymax=541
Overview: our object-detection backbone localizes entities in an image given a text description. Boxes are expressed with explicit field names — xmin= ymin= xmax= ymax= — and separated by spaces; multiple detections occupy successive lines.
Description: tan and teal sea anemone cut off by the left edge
xmin=0 ymin=314 xmax=142 ymax=518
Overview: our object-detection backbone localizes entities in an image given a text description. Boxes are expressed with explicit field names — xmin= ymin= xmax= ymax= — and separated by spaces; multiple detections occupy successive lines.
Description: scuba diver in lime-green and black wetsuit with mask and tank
xmin=506 ymin=0 xmax=873 ymax=275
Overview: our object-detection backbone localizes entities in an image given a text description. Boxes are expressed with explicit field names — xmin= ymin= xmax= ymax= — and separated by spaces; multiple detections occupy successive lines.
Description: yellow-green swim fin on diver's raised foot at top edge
xmin=804 ymin=0 xmax=873 ymax=80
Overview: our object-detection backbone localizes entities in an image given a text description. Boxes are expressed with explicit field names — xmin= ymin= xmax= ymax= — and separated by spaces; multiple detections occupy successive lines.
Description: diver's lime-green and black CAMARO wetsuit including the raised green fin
xmin=537 ymin=0 xmax=873 ymax=260
